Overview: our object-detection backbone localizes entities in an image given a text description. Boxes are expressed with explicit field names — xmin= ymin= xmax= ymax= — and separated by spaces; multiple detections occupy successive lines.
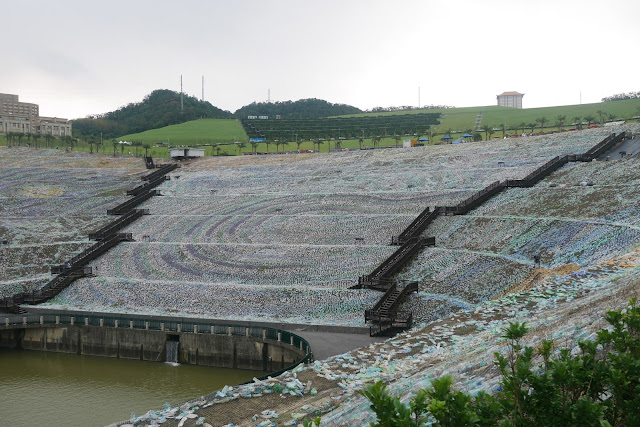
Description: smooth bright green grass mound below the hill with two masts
xmin=116 ymin=119 xmax=247 ymax=146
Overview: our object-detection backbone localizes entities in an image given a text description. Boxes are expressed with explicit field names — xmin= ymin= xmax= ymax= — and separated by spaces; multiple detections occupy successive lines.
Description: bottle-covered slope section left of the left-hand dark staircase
xmin=0 ymin=147 xmax=145 ymax=296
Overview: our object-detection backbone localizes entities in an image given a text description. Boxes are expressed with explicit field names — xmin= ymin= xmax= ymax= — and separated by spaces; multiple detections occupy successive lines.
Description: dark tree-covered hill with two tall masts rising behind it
xmin=73 ymin=89 xmax=233 ymax=138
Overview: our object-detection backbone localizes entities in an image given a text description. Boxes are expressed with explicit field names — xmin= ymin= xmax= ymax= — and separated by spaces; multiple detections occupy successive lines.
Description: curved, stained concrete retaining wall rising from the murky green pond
xmin=0 ymin=325 xmax=305 ymax=371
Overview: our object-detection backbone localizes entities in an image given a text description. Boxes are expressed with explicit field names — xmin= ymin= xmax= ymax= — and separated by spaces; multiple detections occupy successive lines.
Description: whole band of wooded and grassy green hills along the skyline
xmin=58 ymin=90 xmax=640 ymax=157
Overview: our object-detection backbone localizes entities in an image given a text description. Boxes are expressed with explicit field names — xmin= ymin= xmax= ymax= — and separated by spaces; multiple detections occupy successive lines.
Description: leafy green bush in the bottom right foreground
xmin=361 ymin=299 xmax=640 ymax=427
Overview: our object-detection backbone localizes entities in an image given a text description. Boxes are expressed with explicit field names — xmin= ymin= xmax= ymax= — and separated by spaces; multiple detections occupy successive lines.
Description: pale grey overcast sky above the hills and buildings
xmin=0 ymin=0 xmax=640 ymax=118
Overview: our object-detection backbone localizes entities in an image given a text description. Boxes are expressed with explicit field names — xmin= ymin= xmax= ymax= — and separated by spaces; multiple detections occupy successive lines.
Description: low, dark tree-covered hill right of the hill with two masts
xmin=234 ymin=98 xmax=362 ymax=119
